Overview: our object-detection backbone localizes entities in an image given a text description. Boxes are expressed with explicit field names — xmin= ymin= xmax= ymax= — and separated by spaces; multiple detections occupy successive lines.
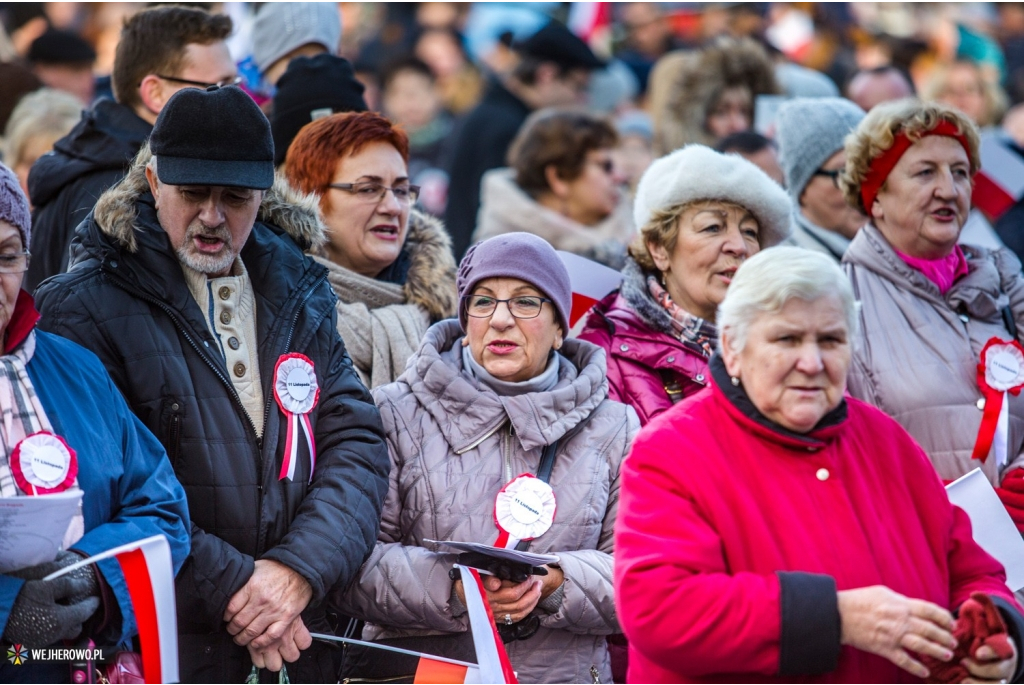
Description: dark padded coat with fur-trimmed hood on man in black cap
xmin=37 ymin=156 xmax=389 ymax=682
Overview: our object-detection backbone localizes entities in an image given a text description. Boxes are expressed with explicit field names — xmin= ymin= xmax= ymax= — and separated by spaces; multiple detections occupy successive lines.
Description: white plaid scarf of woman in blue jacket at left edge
xmin=0 ymin=331 xmax=85 ymax=549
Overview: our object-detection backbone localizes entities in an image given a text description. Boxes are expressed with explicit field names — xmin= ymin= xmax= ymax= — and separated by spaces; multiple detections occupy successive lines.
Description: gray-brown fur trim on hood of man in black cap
xmin=93 ymin=143 xmax=326 ymax=253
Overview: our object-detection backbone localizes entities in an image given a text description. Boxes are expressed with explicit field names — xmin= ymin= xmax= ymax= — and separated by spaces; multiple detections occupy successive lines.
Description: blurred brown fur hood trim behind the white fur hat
xmin=648 ymin=38 xmax=780 ymax=155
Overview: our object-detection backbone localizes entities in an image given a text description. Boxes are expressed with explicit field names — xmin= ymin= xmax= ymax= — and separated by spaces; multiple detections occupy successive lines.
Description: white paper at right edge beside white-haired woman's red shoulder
xmin=946 ymin=469 xmax=1024 ymax=592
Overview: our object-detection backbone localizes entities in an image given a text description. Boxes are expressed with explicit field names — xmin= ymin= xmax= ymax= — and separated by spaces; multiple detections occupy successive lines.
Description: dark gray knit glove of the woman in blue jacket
xmin=3 ymin=573 xmax=99 ymax=648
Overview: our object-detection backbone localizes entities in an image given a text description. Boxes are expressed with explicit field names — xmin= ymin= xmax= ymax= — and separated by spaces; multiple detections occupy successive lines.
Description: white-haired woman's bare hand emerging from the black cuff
xmin=838 ymin=585 xmax=954 ymax=678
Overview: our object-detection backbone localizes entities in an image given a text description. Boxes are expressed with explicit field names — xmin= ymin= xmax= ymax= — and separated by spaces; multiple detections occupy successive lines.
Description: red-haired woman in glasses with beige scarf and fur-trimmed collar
xmin=285 ymin=112 xmax=456 ymax=388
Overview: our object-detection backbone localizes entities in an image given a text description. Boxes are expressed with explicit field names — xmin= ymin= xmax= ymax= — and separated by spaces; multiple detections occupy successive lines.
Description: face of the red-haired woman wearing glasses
xmin=324 ymin=141 xmax=412 ymax=277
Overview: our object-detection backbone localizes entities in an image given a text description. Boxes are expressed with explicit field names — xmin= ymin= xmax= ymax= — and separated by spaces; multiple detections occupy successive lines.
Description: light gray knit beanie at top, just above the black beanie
xmin=253 ymin=2 xmax=341 ymax=73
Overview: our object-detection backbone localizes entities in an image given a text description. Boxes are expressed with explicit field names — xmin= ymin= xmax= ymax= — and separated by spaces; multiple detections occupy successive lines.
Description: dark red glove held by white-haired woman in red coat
xmin=921 ymin=592 xmax=1014 ymax=683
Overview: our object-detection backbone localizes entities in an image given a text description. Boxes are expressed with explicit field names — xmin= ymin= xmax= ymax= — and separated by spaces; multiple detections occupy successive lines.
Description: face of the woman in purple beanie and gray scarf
xmin=463 ymin=279 xmax=563 ymax=383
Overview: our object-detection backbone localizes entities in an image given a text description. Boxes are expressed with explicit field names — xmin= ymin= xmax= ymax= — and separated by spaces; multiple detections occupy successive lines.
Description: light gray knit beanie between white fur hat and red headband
xmin=775 ymin=97 xmax=865 ymax=202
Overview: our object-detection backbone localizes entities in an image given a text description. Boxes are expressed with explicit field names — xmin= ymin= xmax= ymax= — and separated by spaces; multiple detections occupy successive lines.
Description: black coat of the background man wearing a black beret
xmin=444 ymin=81 xmax=529 ymax=262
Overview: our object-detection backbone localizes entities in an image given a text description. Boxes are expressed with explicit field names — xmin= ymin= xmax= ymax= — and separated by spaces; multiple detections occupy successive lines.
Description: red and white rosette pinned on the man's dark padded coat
xmin=273 ymin=352 xmax=319 ymax=481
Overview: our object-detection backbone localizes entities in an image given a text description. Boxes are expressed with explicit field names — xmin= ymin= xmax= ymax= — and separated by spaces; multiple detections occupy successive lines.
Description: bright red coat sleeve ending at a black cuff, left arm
xmin=615 ymin=421 xmax=781 ymax=677
